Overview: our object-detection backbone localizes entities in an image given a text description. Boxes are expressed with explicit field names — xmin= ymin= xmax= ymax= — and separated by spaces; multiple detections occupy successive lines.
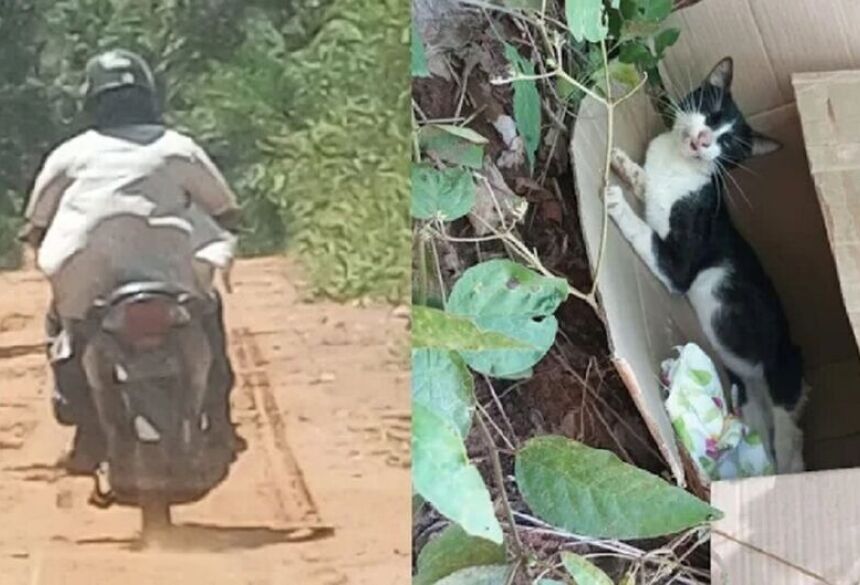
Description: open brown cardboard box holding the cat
xmin=571 ymin=0 xmax=860 ymax=585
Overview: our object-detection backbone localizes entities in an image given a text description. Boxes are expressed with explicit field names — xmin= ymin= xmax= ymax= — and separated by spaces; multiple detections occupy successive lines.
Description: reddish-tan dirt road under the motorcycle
xmin=0 ymin=258 xmax=411 ymax=585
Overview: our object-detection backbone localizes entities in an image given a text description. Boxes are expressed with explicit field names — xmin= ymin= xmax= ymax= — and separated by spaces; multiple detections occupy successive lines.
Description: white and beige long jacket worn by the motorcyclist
xmin=26 ymin=125 xmax=237 ymax=319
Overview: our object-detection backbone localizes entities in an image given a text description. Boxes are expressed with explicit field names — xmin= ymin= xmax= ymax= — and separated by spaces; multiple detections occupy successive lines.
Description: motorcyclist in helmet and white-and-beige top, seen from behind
xmin=21 ymin=50 xmax=245 ymax=473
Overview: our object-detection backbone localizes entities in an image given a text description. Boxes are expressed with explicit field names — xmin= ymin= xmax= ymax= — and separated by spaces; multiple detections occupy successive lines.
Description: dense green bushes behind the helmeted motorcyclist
xmin=0 ymin=0 xmax=410 ymax=300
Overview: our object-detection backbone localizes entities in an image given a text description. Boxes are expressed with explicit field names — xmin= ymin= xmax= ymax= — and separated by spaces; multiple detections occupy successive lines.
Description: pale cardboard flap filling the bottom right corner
xmin=711 ymin=469 xmax=860 ymax=585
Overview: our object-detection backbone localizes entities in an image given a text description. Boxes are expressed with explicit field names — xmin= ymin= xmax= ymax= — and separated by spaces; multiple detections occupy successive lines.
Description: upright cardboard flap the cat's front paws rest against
xmin=571 ymin=93 xmax=720 ymax=485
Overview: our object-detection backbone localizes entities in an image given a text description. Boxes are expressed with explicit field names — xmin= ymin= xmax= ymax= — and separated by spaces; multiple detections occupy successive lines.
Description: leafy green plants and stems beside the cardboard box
xmin=411 ymin=0 xmax=721 ymax=585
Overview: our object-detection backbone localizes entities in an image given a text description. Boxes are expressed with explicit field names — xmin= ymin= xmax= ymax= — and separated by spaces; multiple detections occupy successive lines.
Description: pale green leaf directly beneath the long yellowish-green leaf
xmin=412 ymin=349 xmax=475 ymax=440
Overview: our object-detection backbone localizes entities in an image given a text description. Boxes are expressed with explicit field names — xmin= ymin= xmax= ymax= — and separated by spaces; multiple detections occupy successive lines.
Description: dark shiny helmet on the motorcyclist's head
xmin=83 ymin=49 xmax=156 ymax=103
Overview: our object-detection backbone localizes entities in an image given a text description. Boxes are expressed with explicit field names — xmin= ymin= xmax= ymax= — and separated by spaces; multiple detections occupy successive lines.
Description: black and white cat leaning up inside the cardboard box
xmin=606 ymin=58 xmax=806 ymax=473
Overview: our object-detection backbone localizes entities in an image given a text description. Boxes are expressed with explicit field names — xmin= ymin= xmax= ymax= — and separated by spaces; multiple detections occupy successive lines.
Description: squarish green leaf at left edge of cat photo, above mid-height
xmin=412 ymin=164 xmax=475 ymax=221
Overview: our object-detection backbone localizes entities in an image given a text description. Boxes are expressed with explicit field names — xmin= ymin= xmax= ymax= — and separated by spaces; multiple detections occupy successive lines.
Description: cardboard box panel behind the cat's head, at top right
xmin=663 ymin=0 xmax=860 ymax=116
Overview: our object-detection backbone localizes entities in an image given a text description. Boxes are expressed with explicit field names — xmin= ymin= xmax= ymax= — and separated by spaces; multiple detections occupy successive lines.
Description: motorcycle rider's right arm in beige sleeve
xmin=183 ymin=147 xmax=240 ymax=231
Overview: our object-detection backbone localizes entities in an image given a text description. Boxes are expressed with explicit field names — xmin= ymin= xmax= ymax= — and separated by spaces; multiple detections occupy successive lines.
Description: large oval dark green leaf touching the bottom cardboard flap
xmin=516 ymin=436 xmax=721 ymax=540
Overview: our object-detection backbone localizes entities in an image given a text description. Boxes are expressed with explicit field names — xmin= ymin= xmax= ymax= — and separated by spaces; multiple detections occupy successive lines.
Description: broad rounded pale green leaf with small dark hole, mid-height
xmin=448 ymin=260 xmax=570 ymax=377
